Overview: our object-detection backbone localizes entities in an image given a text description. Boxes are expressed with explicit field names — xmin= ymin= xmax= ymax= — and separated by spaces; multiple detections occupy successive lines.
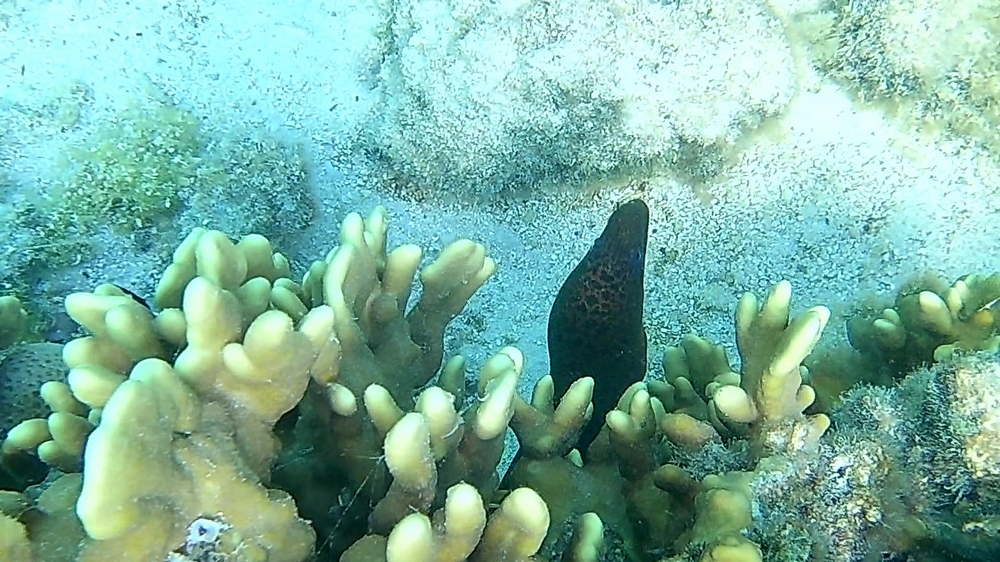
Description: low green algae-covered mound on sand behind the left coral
xmin=46 ymin=88 xmax=312 ymax=239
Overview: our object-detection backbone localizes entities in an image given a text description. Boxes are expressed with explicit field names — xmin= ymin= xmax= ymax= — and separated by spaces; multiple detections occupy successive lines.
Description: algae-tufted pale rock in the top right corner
xmin=802 ymin=0 xmax=1000 ymax=154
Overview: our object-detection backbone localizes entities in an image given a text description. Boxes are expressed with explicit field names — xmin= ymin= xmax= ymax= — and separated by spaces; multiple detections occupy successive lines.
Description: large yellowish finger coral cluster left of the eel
xmin=4 ymin=210 xmax=500 ymax=560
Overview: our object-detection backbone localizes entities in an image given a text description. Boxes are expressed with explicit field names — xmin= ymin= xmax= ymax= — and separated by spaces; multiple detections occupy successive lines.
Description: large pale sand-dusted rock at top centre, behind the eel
xmin=363 ymin=0 xmax=795 ymax=198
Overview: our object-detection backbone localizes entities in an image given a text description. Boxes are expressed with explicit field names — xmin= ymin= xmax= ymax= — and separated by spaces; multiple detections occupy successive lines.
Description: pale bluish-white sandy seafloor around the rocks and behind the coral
xmin=0 ymin=0 xmax=1000 ymax=406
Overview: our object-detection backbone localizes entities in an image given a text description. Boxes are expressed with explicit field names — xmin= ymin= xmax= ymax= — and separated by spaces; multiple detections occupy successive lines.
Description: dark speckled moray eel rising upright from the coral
xmin=548 ymin=199 xmax=649 ymax=455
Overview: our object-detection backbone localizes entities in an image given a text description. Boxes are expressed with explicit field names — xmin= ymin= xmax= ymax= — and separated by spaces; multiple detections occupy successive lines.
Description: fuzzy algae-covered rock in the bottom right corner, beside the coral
xmin=817 ymin=352 xmax=1000 ymax=561
